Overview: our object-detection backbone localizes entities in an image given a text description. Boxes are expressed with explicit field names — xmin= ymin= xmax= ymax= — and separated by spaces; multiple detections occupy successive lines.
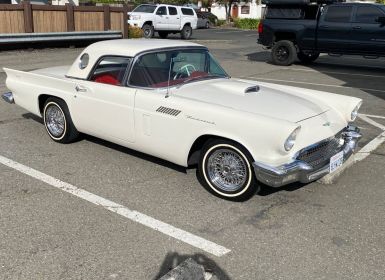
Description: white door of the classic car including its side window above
xmin=71 ymin=56 xmax=136 ymax=142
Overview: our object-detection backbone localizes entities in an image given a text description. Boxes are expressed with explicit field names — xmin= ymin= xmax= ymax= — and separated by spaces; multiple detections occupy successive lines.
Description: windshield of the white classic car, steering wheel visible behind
xmin=129 ymin=49 xmax=228 ymax=88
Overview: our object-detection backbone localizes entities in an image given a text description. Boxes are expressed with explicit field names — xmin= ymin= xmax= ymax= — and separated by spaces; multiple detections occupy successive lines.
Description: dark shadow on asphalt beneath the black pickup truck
xmin=245 ymin=51 xmax=385 ymax=100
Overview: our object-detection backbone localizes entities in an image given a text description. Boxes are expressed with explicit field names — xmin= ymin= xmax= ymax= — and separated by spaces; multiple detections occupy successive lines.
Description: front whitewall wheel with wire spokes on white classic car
xmin=198 ymin=139 xmax=259 ymax=200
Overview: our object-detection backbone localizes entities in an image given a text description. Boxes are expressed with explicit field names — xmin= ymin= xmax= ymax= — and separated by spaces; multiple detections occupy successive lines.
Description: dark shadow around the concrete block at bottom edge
xmin=153 ymin=252 xmax=230 ymax=280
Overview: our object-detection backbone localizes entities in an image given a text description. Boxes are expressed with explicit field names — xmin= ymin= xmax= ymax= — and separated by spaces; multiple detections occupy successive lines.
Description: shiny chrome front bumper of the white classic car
xmin=253 ymin=125 xmax=361 ymax=187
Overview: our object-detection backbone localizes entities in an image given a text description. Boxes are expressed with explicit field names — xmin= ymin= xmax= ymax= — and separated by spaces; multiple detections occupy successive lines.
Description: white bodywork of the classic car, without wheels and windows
xmin=4 ymin=39 xmax=361 ymax=197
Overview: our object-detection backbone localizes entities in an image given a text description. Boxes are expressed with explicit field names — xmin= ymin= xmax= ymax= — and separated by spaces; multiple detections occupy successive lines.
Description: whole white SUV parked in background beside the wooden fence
xmin=128 ymin=4 xmax=198 ymax=39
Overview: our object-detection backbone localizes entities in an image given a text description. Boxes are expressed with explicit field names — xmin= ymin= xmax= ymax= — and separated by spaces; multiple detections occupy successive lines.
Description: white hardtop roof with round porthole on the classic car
xmin=67 ymin=39 xmax=204 ymax=79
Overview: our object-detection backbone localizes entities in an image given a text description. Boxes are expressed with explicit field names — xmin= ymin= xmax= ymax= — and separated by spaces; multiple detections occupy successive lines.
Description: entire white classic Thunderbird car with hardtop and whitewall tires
xmin=3 ymin=39 xmax=361 ymax=199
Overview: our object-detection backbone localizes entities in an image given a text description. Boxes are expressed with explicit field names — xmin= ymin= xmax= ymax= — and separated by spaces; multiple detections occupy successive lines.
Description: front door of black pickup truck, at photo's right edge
xmin=352 ymin=5 xmax=385 ymax=54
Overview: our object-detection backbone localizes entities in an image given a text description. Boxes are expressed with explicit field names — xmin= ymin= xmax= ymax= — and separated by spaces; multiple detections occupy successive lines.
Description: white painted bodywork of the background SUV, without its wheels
xmin=128 ymin=4 xmax=198 ymax=32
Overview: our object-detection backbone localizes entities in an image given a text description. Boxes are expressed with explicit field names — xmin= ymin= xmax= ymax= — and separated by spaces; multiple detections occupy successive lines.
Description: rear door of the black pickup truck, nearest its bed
xmin=317 ymin=4 xmax=353 ymax=52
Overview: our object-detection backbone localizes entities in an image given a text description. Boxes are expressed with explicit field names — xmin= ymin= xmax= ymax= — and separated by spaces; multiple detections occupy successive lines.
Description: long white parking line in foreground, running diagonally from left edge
xmin=0 ymin=155 xmax=230 ymax=257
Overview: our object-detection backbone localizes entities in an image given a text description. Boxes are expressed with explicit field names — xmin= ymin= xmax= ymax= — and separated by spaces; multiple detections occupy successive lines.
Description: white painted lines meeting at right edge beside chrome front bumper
xmin=318 ymin=114 xmax=385 ymax=184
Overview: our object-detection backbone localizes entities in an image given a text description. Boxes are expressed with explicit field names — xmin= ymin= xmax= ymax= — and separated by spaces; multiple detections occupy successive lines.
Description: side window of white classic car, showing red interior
xmin=89 ymin=56 xmax=131 ymax=86
